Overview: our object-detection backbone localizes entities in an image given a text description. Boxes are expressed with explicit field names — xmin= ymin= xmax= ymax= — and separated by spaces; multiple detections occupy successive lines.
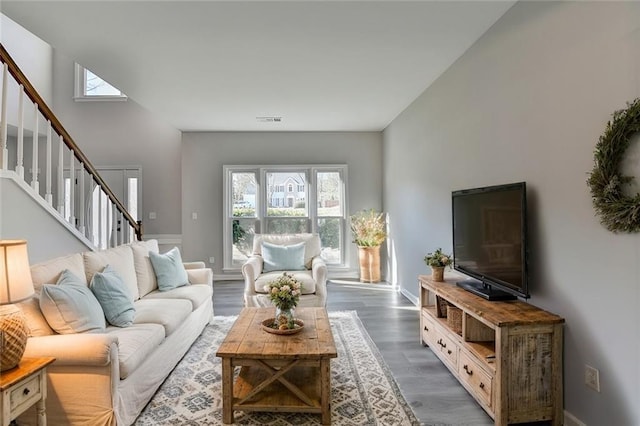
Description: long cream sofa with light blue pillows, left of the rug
xmin=18 ymin=240 xmax=213 ymax=426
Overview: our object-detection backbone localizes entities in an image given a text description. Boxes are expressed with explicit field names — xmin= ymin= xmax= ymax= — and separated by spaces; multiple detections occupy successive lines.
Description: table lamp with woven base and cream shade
xmin=0 ymin=240 xmax=34 ymax=371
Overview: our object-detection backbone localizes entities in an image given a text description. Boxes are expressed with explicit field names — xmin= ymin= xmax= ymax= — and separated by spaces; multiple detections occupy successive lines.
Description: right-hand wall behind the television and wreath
xmin=383 ymin=2 xmax=640 ymax=425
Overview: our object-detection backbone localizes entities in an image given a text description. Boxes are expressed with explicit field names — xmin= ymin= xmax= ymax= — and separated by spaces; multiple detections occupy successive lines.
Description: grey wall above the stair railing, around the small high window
xmin=53 ymin=51 xmax=182 ymax=235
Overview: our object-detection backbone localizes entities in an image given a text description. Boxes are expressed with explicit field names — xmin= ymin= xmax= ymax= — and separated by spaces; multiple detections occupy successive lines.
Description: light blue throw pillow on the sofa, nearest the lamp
xmin=40 ymin=269 xmax=106 ymax=334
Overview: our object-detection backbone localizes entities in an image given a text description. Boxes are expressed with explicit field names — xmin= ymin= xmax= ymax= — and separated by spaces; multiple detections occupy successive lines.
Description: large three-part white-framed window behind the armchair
xmin=223 ymin=165 xmax=347 ymax=272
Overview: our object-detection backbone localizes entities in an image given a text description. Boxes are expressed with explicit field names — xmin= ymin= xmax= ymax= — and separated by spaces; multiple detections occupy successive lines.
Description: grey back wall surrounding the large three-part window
xmin=182 ymin=132 xmax=382 ymax=275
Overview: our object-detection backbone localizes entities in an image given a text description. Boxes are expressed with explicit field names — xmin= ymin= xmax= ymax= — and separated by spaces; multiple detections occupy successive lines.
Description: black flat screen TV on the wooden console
xmin=451 ymin=182 xmax=529 ymax=300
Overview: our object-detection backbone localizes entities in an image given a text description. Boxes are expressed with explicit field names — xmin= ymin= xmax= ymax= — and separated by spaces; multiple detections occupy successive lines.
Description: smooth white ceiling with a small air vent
xmin=0 ymin=0 xmax=514 ymax=131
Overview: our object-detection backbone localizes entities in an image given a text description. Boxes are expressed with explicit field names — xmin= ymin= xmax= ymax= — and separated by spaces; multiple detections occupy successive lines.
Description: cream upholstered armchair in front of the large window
xmin=242 ymin=233 xmax=327 ymax=308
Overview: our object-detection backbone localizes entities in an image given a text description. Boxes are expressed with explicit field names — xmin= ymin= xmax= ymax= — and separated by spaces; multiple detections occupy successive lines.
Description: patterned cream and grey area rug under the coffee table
xmin=135 ymin=311 xmax=419 ymax=426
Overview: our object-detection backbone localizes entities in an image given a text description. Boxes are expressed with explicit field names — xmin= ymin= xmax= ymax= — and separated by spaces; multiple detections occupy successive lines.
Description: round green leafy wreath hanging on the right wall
xmin=587 ymin=98 xmax=640 ymax=233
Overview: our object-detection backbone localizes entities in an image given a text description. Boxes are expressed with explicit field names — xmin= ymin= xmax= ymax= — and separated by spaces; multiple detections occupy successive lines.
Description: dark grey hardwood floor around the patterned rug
xmin=213 ymin=280 xmax=493 ymax=426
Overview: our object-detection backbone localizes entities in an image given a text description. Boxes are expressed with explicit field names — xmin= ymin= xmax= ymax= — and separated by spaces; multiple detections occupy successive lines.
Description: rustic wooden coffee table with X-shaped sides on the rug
xmin=216 ymin=308 xmax=338 ymax=425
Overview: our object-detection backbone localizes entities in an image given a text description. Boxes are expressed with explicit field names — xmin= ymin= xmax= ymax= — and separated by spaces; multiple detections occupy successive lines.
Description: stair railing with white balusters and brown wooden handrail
xmin=0 ymin=43 xmax=142 ymax=248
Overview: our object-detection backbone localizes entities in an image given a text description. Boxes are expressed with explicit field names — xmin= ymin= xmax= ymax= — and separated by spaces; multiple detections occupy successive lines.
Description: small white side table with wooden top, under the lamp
xmin=0 ymin=357 xmax=55 ymax=426
